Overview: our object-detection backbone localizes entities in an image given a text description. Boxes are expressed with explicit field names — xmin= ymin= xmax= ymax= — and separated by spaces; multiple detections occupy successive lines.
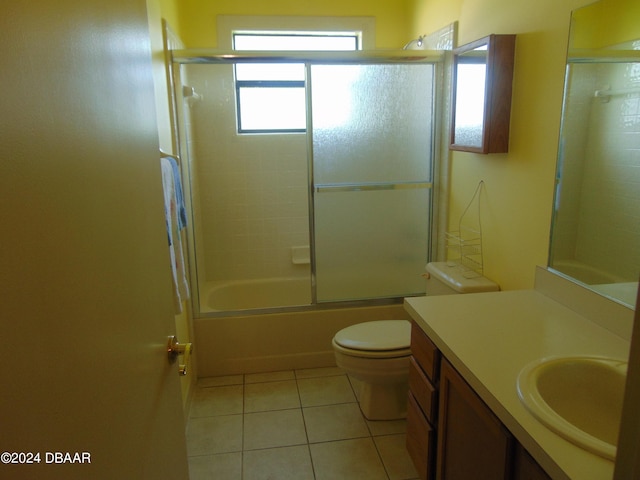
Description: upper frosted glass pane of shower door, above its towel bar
xmin=311 ymin=65 xmax=433 ymax=183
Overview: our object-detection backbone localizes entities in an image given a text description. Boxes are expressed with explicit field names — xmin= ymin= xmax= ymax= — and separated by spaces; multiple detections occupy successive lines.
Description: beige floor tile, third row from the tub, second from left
xmin=244 ymin=409 xmax=307 ymax=450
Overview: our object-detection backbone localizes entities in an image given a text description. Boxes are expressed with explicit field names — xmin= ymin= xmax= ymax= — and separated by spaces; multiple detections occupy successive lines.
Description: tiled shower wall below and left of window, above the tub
xmin=188 ymin=65 xmax=309 ymax=282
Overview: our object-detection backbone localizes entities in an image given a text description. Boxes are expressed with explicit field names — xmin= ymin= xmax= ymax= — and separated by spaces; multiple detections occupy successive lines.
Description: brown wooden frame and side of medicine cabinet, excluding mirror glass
xmin=449 ymin=34 xmax=516 ymax=154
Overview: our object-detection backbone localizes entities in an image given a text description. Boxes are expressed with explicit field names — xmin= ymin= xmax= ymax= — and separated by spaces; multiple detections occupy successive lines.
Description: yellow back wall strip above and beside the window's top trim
xmin=172 ymin=0 xmax=411 ymax=48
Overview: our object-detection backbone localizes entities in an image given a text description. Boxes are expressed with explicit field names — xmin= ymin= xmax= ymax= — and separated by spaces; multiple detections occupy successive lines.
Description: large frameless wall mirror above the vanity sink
xmin=549 ymin=0 xmax=640 ymax=306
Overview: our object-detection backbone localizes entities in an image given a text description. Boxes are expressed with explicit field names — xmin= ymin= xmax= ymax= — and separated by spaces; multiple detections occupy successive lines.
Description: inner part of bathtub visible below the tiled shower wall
xmin=205 ymin=277 xmax=311 ymax=312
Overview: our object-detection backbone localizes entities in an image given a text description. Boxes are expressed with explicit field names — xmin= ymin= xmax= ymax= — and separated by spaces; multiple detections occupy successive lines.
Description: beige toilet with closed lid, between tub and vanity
xmin=332 ymin=262 xmax=500 ymax=420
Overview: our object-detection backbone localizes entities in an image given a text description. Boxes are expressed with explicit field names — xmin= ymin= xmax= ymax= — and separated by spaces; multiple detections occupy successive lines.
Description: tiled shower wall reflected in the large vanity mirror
xmin=554 ymin=44 xmax=640 ymax=281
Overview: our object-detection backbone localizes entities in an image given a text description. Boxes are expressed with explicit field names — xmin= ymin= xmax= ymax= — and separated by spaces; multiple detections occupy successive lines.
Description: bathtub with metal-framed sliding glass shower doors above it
xmin=173 ymin=50 xmax=443 ymax=376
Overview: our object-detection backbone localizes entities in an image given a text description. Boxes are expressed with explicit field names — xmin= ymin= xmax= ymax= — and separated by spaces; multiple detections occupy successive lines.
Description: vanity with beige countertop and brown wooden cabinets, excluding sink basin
xmin=405 ymin=267 xmax=633 ymax=480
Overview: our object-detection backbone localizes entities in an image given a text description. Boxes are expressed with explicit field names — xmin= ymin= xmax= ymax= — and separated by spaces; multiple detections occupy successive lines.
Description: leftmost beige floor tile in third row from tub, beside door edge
xmin=187 ymin=415 xmax=242 ymax=456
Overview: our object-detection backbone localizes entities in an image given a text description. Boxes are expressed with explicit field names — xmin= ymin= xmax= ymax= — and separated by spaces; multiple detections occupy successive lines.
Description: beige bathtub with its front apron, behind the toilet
xmin=193 ymin=279 xmax=410 ymax=377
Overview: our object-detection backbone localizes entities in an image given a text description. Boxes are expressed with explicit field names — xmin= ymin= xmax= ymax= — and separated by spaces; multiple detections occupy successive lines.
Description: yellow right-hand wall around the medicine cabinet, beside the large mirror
xmin=412 ymin=0 xmax=591 ymax=290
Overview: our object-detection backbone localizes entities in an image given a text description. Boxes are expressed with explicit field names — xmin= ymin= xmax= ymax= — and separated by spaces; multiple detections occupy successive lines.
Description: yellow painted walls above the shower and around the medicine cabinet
xmin=150 ymin=0 xmax=616 ymax=289
